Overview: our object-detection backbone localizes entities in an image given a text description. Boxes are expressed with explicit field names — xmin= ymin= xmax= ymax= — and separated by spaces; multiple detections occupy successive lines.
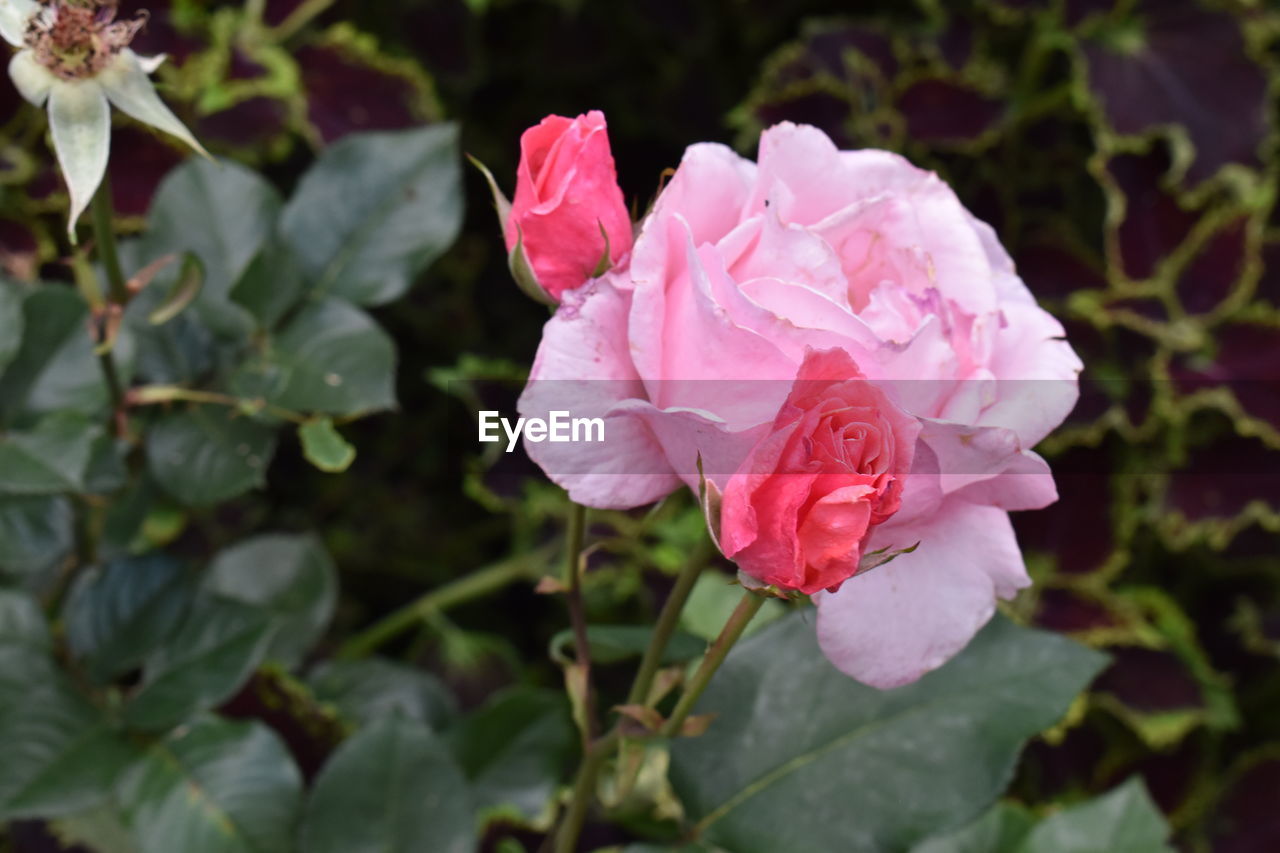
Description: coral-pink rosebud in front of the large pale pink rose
xmin=719 ymin=350 xmax=920 ymax=594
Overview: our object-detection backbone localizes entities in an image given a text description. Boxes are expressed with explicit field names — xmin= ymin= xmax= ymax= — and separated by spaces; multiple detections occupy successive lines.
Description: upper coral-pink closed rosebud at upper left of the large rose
xmin=504 ymin=110 xmax=632 ymax=302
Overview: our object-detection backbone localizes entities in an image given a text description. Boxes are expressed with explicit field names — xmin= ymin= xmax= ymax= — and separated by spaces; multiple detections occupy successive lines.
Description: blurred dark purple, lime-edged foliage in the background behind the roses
xmin=0 ymin=0 xmax=1280 ymax=853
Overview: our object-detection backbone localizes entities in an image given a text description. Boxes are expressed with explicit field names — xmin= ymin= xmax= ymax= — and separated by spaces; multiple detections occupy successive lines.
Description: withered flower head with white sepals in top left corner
xmin=0 ymin=0 xmax=207 ymax=240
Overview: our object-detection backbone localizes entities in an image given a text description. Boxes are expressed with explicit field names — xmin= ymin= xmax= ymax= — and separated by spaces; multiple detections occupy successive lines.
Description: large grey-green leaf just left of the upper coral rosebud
xmin=282 ymin=124 xmax=462 ymax=305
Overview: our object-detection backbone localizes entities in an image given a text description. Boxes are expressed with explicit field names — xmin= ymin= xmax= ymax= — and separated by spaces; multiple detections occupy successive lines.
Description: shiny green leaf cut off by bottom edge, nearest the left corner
xmin=119 ymin=717 xmax=302 ymax=853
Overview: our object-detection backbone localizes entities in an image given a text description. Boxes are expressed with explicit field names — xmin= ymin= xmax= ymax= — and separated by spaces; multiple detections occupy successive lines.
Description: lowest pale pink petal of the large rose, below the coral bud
xmin=814 ymin=497 xmax=1030 ymax=688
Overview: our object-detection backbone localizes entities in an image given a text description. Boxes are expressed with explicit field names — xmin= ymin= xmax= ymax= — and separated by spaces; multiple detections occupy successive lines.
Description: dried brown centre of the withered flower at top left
xmin=27 ymin=0 xmax=146 ymax=79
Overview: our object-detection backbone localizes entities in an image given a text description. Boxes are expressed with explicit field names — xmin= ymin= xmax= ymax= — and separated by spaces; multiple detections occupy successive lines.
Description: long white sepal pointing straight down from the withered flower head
xmin=49 ymin=79 xmax=111 ymax=237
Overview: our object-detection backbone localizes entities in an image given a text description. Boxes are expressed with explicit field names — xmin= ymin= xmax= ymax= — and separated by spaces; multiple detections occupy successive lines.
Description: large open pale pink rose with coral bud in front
xmin=521 ymin=124 xmax=1082 ymax=688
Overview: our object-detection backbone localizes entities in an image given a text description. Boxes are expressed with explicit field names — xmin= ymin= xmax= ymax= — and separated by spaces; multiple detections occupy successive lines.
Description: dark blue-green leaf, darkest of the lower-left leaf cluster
xmin=63 ymin=555 xmax=193 ymax=684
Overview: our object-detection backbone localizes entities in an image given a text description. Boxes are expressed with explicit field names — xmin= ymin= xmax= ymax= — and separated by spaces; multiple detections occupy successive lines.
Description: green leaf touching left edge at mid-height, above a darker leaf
xmin=0 ymin=411 xmax=105 ymax=494
